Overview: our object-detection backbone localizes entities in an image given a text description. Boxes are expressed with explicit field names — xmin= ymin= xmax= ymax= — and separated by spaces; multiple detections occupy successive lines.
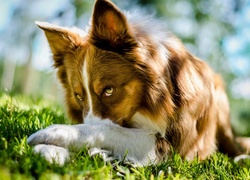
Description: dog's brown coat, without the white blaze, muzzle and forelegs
xmin=36 ymin=0 xmax=248 ymax=162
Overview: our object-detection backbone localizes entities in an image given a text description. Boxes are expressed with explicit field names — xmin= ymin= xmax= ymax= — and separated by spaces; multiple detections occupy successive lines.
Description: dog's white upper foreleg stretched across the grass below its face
xmin=28 ymin=120 xmax=158 ymax=165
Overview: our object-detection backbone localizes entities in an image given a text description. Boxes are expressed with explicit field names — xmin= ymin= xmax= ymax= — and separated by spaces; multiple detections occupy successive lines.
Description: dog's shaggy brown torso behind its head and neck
xmin=158 ymin=41 xmax=246 ymax=159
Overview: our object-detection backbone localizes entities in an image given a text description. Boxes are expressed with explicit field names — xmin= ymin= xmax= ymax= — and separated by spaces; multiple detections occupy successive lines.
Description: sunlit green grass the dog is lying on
xmin=0 ymin=92 xmax=250 ymax=180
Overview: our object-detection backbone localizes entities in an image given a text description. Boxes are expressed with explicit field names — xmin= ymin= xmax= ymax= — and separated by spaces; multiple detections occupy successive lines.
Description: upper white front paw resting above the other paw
xmin=28 ymin=125 xmax=78 ymax=148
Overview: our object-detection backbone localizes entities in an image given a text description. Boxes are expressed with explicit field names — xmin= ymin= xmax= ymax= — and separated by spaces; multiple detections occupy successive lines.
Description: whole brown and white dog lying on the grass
xmin=28 ymin=0 xmax=249 ymax=165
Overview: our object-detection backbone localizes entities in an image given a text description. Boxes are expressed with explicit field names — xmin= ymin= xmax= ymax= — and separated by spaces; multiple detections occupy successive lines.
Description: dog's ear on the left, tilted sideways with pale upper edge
xmin=36 ymin=22 xmax=83 ymax=68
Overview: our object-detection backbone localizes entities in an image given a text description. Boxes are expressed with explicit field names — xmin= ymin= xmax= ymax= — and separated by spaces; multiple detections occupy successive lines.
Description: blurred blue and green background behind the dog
xmin=0 ymin=0 xmax=250 ymax=135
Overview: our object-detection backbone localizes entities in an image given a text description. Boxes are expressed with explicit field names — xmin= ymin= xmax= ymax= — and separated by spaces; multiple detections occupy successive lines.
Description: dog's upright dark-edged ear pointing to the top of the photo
xmin=90 ymin=0 xmax=135 ymax=51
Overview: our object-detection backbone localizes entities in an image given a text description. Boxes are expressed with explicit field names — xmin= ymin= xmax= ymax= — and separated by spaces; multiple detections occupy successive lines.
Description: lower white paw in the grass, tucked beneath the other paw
xmin=34 ymin=144 xmax=70 ymax=165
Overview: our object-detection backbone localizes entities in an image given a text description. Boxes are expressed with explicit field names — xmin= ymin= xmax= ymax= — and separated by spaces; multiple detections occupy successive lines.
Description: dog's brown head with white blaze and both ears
xmin=37 ymin=0 xmax=176 ymax=132
